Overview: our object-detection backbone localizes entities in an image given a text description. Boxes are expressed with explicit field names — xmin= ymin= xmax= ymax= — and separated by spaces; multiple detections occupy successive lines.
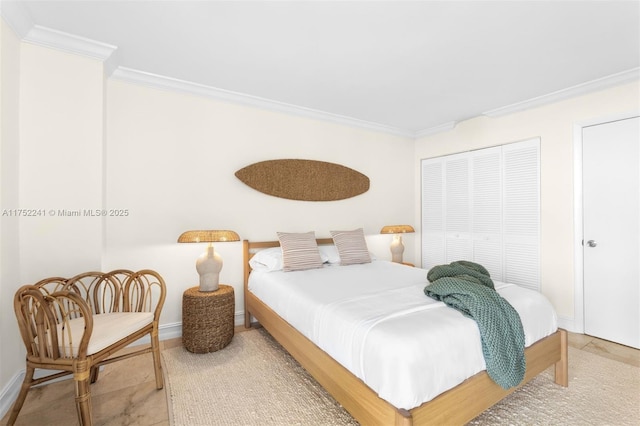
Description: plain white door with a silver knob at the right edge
xmin=582 ymin=117 xmax=640 ymax=348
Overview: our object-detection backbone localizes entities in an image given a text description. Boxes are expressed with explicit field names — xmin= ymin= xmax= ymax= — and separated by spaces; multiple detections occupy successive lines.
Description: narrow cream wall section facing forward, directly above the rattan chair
xmin=19 ymin=43 xmax=104 ymax=282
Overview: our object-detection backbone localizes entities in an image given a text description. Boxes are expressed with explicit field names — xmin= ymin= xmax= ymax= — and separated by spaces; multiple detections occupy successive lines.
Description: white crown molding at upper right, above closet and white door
xmin=482 ymin=68 xmax=640 ymax=117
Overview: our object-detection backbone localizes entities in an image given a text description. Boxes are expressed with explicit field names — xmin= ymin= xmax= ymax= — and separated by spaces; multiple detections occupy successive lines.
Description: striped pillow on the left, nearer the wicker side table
xmin=278 ymin=231 xmax=322 ymax=272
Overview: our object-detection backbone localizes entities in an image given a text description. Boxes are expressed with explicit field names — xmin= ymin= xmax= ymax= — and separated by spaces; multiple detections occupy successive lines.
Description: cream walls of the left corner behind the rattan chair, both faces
xmin=0 ymin=30 xmax=104 ymax=412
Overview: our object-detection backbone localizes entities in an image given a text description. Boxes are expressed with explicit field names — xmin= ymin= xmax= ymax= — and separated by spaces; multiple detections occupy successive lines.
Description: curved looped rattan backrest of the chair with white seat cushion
xmin=14 ymin=269 xmax=166 ymax=360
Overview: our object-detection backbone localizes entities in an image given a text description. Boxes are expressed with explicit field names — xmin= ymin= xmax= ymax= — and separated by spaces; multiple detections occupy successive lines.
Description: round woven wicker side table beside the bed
xmin=182 ymin=284 xmax=235 ymax=353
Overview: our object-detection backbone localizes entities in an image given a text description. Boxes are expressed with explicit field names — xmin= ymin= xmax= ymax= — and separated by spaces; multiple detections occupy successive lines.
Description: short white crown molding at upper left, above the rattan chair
xmin=23 ymin=25 xmax=118 ymax=61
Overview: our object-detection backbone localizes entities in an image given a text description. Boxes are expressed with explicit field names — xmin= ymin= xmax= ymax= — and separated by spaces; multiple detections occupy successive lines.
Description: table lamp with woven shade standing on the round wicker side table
xmin=178 ymin=230 xmax=240 ymax=292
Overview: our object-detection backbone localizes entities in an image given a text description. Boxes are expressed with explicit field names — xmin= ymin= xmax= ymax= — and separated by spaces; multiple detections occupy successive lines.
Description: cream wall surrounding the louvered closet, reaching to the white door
xmin=414 ymin=82 xmax=640 ymax=329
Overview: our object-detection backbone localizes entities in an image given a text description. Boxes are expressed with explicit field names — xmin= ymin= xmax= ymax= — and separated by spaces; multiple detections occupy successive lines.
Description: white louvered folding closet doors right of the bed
xmin=422 ymin=139 xmax=540 ymax=290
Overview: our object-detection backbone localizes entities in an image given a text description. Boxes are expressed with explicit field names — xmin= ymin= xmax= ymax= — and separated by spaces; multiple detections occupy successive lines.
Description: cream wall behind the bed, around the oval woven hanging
xmin=104 ymin=79 xmax=414 ymax=325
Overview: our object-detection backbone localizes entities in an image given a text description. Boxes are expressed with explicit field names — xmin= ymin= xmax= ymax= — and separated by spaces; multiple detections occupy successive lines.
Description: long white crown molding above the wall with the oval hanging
xmin=111 ymin=67 xmax=415 ymax=138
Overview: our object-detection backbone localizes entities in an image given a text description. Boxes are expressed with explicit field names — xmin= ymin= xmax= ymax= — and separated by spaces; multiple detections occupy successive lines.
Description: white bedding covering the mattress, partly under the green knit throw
xmin=249 ymin=261 xmax=557 ymax=409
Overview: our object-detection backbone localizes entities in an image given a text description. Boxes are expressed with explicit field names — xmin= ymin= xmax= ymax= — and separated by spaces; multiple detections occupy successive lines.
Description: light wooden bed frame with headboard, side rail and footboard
xmin=243 ymin=238 xmax=569 ymax=426
